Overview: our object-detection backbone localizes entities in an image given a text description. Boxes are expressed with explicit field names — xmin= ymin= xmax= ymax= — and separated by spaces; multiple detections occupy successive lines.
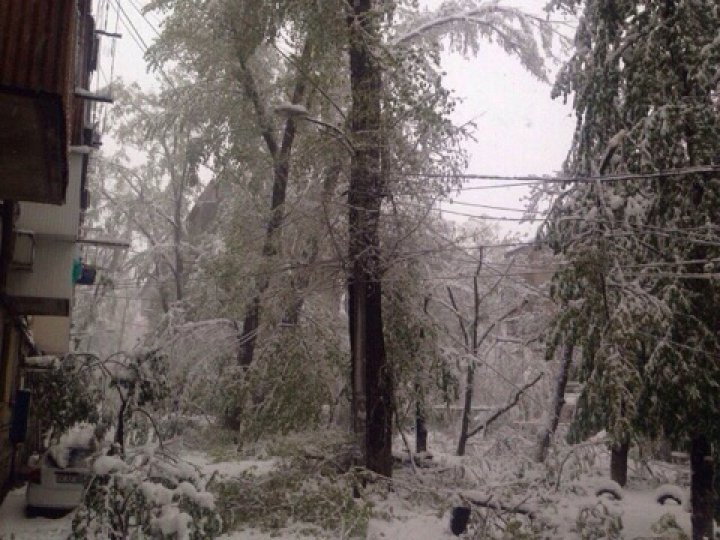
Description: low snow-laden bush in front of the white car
xmin=71 ymin=449 xmax=222 ymax=540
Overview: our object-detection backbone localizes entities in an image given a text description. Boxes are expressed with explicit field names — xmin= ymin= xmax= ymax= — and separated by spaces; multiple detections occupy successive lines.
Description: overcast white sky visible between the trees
xmin=100 ymin=0 xmax=574 ymax=237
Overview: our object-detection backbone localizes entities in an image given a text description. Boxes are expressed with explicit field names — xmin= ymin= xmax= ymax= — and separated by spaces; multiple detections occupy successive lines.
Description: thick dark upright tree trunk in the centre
xmin=347 ymin=0 xmax=393 ymax=476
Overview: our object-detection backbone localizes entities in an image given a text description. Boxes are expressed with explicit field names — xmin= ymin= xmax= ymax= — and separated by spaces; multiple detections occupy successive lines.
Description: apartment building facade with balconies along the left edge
xmin=0 ymin=0 xmax=102 ymax=500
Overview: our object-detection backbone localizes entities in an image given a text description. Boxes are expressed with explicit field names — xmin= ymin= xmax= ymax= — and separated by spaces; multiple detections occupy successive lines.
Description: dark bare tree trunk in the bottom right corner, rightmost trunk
xmin=690 ymin=435 xmax=715 ymax=540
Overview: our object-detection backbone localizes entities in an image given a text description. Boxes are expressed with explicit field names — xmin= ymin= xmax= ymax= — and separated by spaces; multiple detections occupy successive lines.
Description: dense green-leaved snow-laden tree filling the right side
xmin=546 ymin=0 xmax=720 ymax=538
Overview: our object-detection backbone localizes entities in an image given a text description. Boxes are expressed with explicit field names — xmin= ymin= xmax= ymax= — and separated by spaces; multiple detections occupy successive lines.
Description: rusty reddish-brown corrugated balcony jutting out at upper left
xmin=0 ymin=0 xmax=77 ymax=204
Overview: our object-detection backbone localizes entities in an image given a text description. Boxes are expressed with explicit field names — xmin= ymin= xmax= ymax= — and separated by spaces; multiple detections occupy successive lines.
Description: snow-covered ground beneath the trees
xmin=0 ymin=440 xmax=690 ymax=540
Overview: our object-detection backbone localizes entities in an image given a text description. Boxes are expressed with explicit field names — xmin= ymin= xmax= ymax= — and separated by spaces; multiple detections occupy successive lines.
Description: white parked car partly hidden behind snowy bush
xmin=25 ymin=446 xmax=92 ymax=516
